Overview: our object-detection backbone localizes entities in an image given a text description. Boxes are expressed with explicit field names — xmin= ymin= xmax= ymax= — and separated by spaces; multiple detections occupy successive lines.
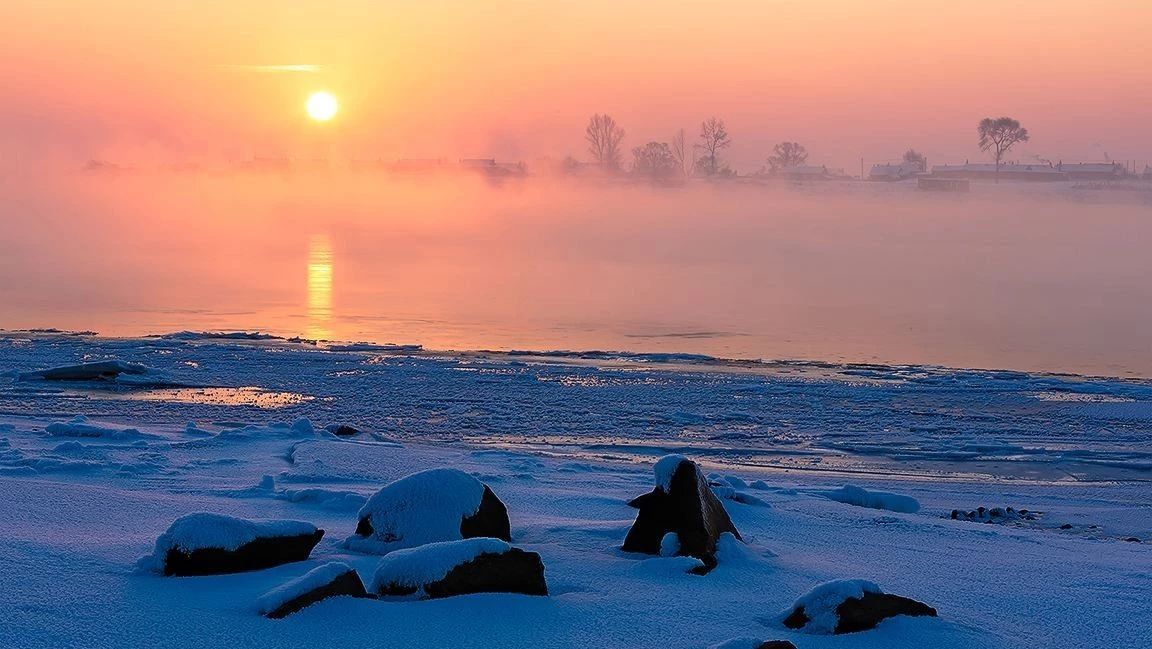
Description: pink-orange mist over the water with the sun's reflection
xmin=0 ymin=172 xmax=1152 ymax=377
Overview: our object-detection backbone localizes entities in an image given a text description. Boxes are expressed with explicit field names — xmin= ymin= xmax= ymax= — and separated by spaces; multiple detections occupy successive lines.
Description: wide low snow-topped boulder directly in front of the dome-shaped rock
xmin=372 ymin=538 xmax=548 ymax=599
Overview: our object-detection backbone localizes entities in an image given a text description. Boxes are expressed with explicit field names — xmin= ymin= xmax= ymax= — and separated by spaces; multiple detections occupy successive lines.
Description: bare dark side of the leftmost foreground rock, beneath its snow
xmin=164 ymin=529 xmax=324 ymax=576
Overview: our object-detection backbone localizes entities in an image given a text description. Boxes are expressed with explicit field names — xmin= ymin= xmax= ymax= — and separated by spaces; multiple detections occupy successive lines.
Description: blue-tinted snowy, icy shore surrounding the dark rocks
xmin=0 ymin=335 xmax=1152 ymax=649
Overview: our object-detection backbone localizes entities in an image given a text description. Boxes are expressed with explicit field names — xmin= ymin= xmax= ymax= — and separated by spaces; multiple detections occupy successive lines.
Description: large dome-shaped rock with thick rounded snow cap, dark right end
xmin=346 ymin=468 xmax=511 ymax=553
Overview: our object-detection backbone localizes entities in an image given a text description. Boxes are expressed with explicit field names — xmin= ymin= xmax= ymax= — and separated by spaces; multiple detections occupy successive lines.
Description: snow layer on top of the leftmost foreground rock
xmin=137 ymin=512 xmax=316 ymax=572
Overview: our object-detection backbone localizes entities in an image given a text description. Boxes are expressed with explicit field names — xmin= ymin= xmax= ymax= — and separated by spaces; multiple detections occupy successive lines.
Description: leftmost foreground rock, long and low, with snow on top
xmin=138 ymin=512 xmax=324 ymax=576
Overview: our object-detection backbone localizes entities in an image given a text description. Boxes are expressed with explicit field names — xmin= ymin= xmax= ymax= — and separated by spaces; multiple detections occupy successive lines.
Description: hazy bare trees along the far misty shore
xmin=584 ymin=113 xmax=1030 ymax=180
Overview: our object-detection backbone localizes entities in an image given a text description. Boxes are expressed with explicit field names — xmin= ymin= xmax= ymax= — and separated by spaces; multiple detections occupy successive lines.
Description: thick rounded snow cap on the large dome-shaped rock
xmin=346 ymin=468 xmax=484 ymax=553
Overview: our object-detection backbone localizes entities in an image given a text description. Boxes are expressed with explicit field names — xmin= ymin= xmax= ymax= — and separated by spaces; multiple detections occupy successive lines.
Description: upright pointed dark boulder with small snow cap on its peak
xmin=622 ymin=455 xmax=742 ymax=572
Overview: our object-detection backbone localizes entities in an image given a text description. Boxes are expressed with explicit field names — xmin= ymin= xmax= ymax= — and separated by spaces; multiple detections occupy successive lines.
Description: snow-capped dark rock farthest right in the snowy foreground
xmin=783 ymin=579 xmax=937 ymax=634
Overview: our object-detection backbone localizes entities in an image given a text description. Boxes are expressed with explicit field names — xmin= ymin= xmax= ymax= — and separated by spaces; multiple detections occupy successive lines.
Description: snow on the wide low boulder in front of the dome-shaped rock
xmin=369 ymin=537 xmax=511 ymax=593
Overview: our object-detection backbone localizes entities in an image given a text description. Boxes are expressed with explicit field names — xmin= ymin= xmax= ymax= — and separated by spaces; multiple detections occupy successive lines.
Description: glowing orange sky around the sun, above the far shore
xmin=0 ymin=0 xmax=1152 ymax=172
